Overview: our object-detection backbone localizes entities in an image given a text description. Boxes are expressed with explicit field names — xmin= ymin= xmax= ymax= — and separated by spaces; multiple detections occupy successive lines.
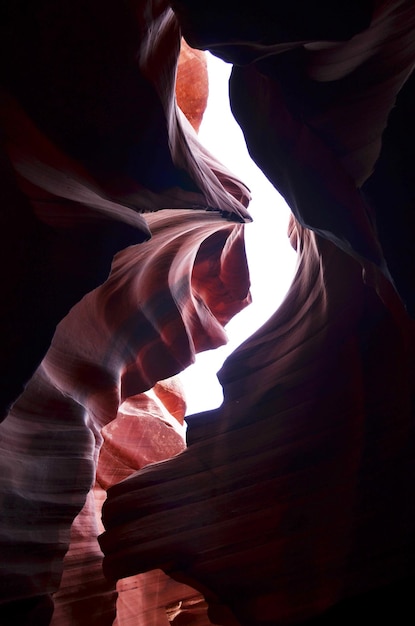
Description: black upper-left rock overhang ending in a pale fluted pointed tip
xmin=0 ymin=0 xmax=250 ymax=419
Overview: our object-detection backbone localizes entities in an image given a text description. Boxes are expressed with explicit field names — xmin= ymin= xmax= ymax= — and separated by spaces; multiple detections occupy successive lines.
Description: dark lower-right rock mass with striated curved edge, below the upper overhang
xmin=101 ymin=216 xmax=415 ymax=626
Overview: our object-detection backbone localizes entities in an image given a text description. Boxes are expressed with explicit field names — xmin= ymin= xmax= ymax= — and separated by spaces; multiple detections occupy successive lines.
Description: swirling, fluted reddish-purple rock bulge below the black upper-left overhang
xmin=1 ymin=202 xmax=249 ymax=617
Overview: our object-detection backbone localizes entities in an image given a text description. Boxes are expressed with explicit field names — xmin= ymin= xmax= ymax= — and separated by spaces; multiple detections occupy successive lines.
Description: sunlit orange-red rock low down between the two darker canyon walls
xmin=51 ymin=388 xmax=210 ymax=626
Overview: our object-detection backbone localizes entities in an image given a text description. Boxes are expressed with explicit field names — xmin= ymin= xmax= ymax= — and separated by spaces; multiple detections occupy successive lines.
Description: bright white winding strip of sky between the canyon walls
xmin=180 ymin=53 xmax=296 ymax=415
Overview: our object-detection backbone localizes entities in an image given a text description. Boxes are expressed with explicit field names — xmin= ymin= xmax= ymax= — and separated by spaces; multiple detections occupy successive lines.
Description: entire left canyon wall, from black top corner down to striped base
xmin=0 ymin=1 xmax=250 ymax=626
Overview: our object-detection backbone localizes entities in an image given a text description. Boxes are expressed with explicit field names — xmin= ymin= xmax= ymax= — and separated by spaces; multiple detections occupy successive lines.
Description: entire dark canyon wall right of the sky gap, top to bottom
xmin=101 ymin=0 xmax=415 ymax=626
